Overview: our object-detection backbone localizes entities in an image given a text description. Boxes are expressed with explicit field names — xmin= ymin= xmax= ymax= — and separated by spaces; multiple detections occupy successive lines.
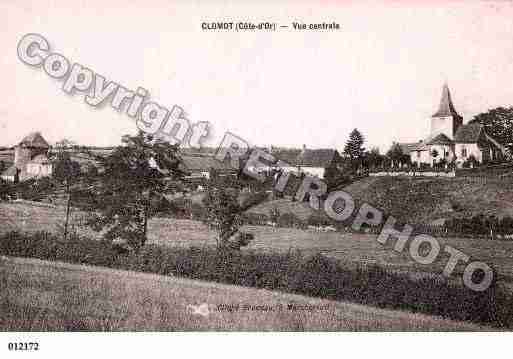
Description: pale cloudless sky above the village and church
xmin=0 ymin=0 xmax=513 ymax=151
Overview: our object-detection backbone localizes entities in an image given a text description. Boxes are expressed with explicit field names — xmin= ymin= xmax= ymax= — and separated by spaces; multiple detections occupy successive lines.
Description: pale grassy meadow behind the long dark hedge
xmin=0 ymin=203 xmax=513 ymax=282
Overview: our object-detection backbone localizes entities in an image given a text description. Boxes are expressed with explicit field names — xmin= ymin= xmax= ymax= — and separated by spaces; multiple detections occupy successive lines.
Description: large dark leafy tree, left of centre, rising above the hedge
xmin=89 ymin=132 xmax=183 ymax=250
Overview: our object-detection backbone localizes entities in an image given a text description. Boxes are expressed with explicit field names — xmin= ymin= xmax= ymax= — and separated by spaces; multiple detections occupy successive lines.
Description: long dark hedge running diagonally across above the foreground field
xmin=0 ymin=232 xmax=513 ymax=328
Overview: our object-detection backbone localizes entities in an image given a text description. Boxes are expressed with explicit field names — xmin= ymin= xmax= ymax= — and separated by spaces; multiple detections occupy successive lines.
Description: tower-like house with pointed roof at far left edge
xmin=0 ymin=132 xmax=53 ymax=182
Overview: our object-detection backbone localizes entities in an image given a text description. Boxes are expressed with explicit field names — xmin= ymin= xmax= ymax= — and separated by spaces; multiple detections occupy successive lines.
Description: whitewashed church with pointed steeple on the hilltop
xmin=401 ymin=84 xmax=505 ymax=167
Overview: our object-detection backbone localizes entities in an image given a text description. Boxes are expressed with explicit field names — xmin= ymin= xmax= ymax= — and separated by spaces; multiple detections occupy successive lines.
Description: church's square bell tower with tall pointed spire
xmin=430 ymin=83 xmax=463 ymax=140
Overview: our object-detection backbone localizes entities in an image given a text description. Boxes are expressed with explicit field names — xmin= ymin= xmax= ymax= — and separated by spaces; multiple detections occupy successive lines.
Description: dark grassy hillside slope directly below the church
xmin=344 ymin=177 xmax=513 ymax=224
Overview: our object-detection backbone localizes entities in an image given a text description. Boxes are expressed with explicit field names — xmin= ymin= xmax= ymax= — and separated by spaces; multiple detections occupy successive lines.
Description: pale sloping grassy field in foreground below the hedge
xmin=0 ymin=257 xmax=489 ymax=331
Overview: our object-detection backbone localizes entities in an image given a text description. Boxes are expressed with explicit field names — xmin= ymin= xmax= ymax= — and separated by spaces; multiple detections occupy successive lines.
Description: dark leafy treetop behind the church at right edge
xmin=469 ymin=106 xmax=513 ymax=153
